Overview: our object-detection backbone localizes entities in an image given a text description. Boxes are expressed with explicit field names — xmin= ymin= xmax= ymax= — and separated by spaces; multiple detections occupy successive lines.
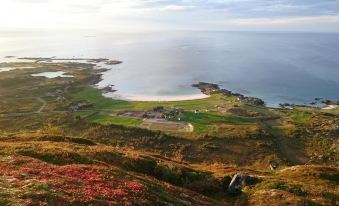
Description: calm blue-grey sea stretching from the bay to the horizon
xmin=0 ymin=32 xmax=339 ymax=105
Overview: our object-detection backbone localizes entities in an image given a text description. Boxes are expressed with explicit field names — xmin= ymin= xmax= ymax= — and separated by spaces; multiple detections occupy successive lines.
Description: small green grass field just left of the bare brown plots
xmin=86 ymin=114 xmax=142 ymax=127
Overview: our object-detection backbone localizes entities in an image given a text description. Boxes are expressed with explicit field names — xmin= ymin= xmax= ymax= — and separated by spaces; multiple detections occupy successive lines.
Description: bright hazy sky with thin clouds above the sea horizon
xmin=0 ymin=0 xmax=339 ymax=32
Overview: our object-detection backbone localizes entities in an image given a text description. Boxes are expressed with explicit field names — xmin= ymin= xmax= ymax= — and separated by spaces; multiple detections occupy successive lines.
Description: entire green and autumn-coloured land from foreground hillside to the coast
xmin=0 ymin=58 xmax=339 ymax=205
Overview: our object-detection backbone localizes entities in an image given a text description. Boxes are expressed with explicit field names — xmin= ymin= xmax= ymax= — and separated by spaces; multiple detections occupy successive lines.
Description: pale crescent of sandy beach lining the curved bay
xmin=103 ymin=92 xmax=210 ymax=102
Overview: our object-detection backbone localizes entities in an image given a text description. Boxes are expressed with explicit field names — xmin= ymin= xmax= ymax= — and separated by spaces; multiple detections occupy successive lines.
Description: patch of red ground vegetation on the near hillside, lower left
xmin=0 ymin=157 xmax=145 ymax=205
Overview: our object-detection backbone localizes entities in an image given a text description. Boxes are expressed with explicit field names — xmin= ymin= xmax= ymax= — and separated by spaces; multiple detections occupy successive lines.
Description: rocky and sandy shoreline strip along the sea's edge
xmin=0 ymin=56 xmax=339 ymax=110
